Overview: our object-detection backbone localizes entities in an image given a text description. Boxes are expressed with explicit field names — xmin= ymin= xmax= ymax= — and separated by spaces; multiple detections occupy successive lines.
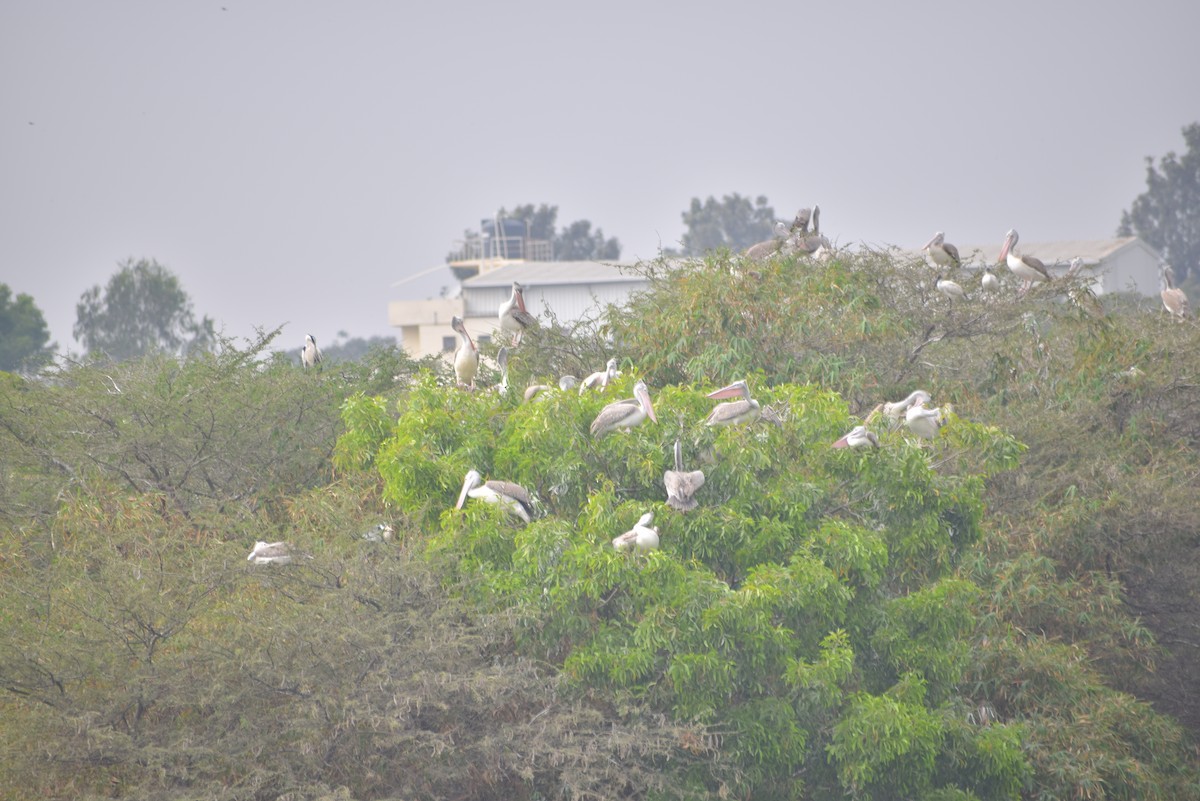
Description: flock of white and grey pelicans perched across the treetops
xmin=247 ymin=211 xmax=1189 ymax=565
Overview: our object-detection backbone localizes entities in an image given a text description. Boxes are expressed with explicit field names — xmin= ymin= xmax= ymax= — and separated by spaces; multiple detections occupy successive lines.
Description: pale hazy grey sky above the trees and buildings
xmin=0 ymin=0 xmax=1200 ymax=350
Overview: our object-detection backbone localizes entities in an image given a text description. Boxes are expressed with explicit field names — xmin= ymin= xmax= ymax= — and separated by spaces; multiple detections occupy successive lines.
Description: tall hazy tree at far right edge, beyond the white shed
xmin=1117 ymin=122 xmax=1200 ymax=281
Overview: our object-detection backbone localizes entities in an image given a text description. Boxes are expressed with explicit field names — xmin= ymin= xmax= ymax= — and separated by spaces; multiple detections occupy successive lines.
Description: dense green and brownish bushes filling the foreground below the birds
xmin=0 ymin=254 xmax=1200 ymax=801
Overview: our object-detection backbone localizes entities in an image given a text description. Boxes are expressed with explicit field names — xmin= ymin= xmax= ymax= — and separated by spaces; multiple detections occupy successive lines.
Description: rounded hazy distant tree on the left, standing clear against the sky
xmin=73 ymin=259 xmax=216 ymax=361
